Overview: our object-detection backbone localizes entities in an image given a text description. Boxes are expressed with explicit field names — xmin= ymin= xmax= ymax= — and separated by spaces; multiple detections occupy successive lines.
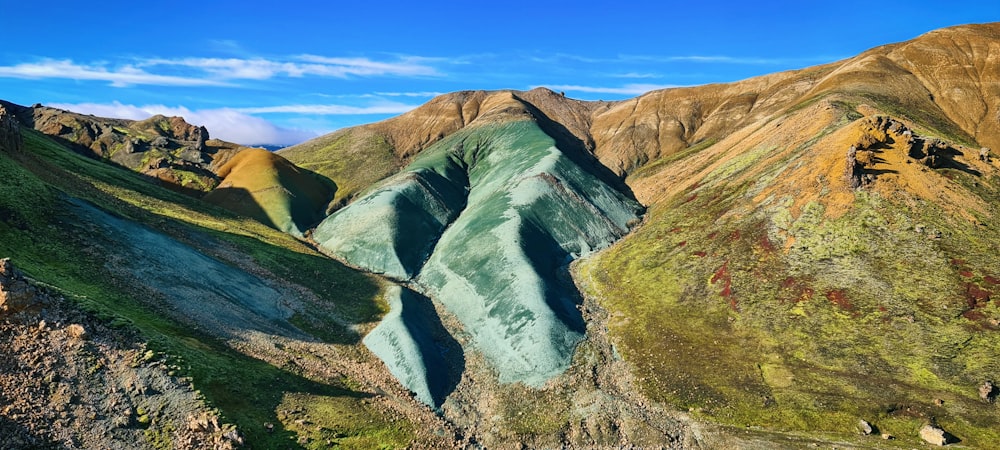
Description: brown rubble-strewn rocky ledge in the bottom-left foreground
xmin=0 ymin=259 xmax=243 ymax=449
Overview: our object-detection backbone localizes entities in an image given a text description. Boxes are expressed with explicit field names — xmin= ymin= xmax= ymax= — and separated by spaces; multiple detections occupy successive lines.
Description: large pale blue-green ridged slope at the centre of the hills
xmin=314 ymin=117 xmax=641 ymax=392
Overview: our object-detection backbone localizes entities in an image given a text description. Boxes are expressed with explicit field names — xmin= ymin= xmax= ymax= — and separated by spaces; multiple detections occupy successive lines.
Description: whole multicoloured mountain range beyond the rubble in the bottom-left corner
xmin=0 ymin=24 xmax=1000 ymax=448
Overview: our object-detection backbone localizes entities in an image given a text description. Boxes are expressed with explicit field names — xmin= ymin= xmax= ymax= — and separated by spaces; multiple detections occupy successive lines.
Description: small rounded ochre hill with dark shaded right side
xmin=204 ymin=148 xmax=336 ymax=236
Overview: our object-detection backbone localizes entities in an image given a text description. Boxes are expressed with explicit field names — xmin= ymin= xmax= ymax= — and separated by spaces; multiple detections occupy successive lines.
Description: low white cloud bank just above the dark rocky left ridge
xmin=47 ymin=102 xmax=320 ymax=145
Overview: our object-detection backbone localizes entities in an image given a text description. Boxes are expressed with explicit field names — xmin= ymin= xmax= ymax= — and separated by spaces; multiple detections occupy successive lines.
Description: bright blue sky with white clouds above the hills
xmin=0 ymin=0 xmax=1000 ymax=145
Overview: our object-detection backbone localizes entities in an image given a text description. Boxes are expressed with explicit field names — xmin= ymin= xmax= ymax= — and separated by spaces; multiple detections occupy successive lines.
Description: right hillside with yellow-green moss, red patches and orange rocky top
xmin=578 ymin=90 xmax=1000 ymax=446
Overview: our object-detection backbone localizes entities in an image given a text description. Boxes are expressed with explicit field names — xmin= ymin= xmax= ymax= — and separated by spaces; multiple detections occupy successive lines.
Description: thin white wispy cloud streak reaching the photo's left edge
xmin=0 ymin=59 xmax=227 ymax=87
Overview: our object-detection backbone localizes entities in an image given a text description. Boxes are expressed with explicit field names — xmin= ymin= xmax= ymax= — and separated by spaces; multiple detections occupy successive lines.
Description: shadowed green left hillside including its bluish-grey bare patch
xmin=0 ymin=121 xmax=447 ymax=448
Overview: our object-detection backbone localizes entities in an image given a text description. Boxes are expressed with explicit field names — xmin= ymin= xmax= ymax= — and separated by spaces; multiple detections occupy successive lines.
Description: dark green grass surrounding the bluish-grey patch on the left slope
xmin=0 ymin=130 xmax=412 ymax=448
